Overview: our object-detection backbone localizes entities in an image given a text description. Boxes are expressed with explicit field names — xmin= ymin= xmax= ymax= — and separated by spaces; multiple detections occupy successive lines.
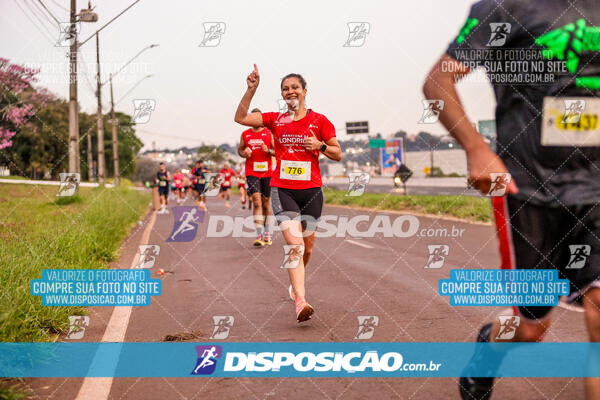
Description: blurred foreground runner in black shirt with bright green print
xmin=423 ymin=0 xmax=600 ymax=400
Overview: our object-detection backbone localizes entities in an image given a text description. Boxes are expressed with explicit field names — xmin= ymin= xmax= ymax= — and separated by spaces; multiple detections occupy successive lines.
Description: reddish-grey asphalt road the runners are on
xmin=26 ymin=193 xmax=587 ymax=400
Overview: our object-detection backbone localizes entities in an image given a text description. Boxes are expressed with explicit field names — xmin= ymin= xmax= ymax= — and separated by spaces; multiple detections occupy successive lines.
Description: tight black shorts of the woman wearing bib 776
xmin=271 ymin=187 xmax=323 ymax=231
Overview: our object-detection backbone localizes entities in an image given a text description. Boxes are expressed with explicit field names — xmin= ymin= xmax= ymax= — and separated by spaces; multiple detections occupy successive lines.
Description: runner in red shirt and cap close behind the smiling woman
xmin=238 ymin=108 xmax=275 ymax=247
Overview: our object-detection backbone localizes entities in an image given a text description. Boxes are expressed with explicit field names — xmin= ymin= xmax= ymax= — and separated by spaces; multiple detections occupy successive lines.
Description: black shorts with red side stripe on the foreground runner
xmin=492 ymin=196 xmax=600 ymax=320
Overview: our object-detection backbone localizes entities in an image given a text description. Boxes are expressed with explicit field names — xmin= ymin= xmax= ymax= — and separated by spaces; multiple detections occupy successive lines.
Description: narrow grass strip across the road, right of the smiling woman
xmin=323 ymin=188 xmax=492 ymax=222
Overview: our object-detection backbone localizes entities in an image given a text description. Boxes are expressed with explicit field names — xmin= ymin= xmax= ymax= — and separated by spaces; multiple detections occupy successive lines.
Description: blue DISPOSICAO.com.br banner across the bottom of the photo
xmin=0 ymin=342 xmax=600 ymax=377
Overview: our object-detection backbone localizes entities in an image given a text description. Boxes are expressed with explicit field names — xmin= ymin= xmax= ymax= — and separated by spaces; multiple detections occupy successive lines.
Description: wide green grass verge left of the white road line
xmin=0 ymin=184 xmax=150 ymax=342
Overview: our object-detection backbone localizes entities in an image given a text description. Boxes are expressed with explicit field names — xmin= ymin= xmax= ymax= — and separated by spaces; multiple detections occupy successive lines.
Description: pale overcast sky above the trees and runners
xmin=0 ymin=0 xmax=495 ymax=149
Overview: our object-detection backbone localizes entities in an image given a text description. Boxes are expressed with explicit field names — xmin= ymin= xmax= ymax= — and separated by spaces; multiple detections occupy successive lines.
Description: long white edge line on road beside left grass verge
xmin=75 ymin=211 xmax=156 ymax=400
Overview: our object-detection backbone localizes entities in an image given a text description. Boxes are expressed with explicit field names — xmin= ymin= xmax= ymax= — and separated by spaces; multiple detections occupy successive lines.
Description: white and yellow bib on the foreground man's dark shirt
xmin=541 ymin=97 xmax=600 ymax=147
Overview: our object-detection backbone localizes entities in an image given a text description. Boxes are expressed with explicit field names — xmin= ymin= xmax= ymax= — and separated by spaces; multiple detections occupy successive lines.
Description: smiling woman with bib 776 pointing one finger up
xmin=235 ymin=64 xmax=342 ymax=322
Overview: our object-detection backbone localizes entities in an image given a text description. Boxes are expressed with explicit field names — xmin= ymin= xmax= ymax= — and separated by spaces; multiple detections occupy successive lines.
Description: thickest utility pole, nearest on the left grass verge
xmin=68 ymin=0 xmax=81 ymax=172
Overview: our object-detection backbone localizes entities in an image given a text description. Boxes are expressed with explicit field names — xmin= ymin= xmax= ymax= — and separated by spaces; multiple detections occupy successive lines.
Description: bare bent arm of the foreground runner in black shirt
xmin=423 ymin=54 xmax=518 ymax=194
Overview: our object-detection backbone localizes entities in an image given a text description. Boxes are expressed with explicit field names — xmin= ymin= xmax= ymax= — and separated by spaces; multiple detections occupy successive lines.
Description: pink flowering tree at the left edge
xmin=0 ymin=57 xmax=53 ymax=150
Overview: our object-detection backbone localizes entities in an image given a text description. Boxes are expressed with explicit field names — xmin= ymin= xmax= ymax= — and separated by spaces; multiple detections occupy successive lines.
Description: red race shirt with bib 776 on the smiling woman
xmin=262 ymin=110 xmax=335 ymax=189
